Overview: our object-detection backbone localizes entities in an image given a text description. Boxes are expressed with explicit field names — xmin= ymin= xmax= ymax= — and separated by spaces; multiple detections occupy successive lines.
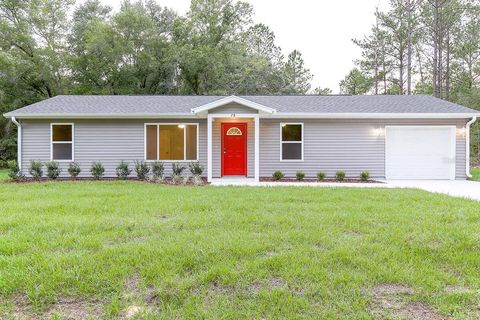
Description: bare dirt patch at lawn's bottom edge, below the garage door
xmin=369 ymin=284 xmax=444 ymax=320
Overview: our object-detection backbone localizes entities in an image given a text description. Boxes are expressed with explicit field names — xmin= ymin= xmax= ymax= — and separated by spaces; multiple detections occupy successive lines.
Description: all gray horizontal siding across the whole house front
xmin=17 ymin=117 xmax=467 ymax=179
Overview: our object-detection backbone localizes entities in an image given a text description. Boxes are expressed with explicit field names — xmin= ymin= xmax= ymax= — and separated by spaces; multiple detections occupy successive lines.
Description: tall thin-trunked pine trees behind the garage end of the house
xmin=340 ymin=0 xmax=480 ymax=162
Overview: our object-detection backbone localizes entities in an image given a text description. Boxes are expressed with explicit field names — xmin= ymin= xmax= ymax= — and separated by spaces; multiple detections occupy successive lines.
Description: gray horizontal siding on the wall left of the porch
xmin=22 ymin=119 xmax=207 ymax=177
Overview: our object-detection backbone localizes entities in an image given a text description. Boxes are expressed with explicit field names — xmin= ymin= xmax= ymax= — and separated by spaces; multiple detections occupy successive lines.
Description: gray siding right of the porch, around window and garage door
xmin=260 ymin=119 xmax=467 ymax=179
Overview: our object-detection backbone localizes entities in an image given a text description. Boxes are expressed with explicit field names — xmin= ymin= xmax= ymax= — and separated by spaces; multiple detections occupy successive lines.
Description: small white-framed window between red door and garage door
xmin=280 ymin=123 xmax=303 ymax=161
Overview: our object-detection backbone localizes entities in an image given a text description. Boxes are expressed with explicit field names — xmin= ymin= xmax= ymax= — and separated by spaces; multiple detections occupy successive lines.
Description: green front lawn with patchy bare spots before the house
xmin=0 ymin=181 xmax=480 ymax=319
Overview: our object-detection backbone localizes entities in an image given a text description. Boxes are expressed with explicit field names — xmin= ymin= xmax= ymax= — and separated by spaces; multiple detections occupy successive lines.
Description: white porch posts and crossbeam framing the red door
xmin=207 ymin=113 xmax=260 ymax=182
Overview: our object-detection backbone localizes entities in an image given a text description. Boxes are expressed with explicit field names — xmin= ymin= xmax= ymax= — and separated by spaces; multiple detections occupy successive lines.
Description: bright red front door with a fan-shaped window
xmin=222 ymin=123 xmax=247 ymax=176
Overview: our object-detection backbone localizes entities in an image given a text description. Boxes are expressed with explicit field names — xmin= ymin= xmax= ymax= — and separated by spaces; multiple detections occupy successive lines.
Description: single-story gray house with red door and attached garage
xmin=4 ymin=95 xmax=479 ymax=180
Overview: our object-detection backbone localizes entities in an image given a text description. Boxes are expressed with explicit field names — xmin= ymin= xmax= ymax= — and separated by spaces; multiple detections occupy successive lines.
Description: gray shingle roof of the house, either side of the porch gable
xmin=5 ymin=95 xmax=478 ymax=117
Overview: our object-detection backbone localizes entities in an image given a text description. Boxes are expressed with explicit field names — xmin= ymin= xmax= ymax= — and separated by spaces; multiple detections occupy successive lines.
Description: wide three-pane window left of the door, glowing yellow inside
xmin=145 ymin=123 xmax=198 ymax=161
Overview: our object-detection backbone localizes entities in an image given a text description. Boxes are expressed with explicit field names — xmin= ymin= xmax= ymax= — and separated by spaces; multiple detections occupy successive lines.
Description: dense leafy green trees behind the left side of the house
xmin=0 ymin=0 xmax=312 ymax=159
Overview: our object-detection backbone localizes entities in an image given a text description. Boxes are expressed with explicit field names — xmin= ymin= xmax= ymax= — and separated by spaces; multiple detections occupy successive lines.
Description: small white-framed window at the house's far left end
xmin=50 ymin=123 xmax=73 ymax=161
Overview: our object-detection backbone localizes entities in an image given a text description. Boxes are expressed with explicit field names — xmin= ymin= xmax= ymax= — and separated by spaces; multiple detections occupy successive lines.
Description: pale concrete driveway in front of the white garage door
xmin=386 ymin=180 xmax=480 ymax=201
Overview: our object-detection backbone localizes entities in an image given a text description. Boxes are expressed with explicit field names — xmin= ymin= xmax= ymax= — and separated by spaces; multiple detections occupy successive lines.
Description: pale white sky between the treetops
xmin=92 ymin=0 xmax=388 ymax=93
